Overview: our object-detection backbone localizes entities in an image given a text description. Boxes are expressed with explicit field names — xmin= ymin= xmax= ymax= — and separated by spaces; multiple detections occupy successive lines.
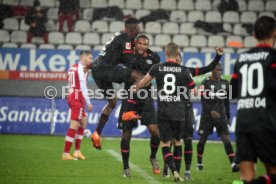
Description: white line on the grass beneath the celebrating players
xmin=107 ymin=149 xmax=160 ymax=184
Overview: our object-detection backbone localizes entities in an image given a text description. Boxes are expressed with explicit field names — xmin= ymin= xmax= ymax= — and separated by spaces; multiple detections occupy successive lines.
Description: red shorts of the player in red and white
xmin=68 ymin=98 xmax=86 ymax=121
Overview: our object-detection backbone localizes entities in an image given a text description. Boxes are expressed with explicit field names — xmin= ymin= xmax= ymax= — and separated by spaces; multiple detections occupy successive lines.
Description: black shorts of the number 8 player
xmin=157 ymin=119 xmax=183 ymax=142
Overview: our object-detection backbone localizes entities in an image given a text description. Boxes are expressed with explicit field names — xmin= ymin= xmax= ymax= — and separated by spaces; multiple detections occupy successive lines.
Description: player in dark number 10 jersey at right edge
xmin=231 ymin=16 xmax=276 ymax=184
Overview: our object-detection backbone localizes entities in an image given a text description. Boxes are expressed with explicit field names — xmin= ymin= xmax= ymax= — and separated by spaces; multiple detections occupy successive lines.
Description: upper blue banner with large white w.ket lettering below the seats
xmin=0 ymin=48 xmax=237 ymax=75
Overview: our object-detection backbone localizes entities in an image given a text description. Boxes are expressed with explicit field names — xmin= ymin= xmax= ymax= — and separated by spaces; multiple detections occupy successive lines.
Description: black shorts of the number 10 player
xmin=236 ymin=130 xmax=276 ymax=166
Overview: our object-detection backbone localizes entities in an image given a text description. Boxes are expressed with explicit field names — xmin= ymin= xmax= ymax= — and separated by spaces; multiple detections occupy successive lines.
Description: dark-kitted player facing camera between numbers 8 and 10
xmin=197 ymin=63 xmax=238 ymax=172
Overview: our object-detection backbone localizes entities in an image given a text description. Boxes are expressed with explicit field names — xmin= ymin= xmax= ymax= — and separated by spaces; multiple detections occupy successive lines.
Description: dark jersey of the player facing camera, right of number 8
xmin=200 ymin=77 xmax=230 ymax=121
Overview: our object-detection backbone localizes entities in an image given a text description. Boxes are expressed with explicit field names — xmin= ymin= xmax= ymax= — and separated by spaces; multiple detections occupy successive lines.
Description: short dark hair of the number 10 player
xmin=254 ymin=16 xmax=276 ymax=40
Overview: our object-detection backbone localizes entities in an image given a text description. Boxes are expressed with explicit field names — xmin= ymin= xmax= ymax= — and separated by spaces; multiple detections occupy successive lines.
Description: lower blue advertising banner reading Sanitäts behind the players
xmin=0 ymin=97 xmax=236 ymax=140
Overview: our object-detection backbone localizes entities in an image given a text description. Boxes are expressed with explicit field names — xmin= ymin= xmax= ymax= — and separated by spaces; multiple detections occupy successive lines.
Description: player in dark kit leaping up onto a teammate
xmin=91 ymin=18 xmax=143 ymax=149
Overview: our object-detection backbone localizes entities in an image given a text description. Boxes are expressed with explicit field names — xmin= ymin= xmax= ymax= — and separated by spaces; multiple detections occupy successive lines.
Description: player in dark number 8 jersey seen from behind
xmin=137 ymin=43 xmax=195 ymax=181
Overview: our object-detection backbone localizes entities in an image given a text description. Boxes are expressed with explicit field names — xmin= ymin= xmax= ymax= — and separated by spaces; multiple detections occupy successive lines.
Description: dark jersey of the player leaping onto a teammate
xmin=94 ymin=31 xmax=133 ymax=66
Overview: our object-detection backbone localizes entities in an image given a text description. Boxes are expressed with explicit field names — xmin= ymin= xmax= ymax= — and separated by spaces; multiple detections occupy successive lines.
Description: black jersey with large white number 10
xmin=231 ymin=44 xmax=276 ymax=132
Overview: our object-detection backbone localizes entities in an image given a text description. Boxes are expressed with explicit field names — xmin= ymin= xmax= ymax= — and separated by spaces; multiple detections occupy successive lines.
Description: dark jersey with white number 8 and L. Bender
xmin=148 ymin=60 xmax=195 ymax=121
